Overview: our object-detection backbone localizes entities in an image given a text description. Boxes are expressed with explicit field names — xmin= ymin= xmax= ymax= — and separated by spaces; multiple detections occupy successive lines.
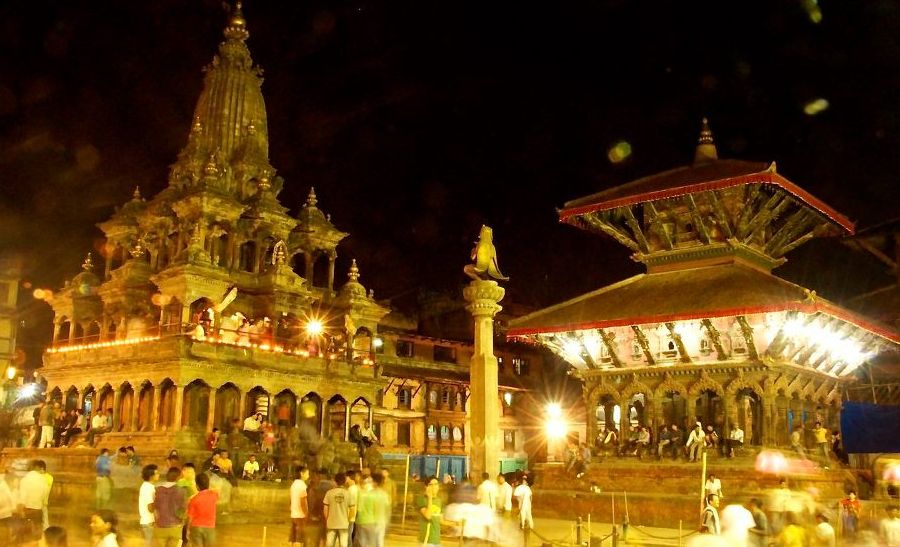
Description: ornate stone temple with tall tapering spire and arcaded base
xmin=42 ymin=4 xmax=389 ymax=447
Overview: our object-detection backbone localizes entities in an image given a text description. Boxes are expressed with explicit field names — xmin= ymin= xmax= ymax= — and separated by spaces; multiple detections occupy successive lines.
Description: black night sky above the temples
xmin=0 ymin=0 xmax=900 ymax=352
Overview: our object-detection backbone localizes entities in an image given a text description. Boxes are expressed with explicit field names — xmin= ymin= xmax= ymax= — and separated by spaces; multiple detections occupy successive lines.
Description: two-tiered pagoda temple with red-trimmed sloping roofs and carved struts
xmin=508 ymin=120 xmax=900 ymax=445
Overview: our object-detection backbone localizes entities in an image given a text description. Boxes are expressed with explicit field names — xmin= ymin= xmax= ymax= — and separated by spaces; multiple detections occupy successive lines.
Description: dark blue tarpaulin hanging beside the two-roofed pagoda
xmin=841 ymin=401 xmax=900 ymax=454
